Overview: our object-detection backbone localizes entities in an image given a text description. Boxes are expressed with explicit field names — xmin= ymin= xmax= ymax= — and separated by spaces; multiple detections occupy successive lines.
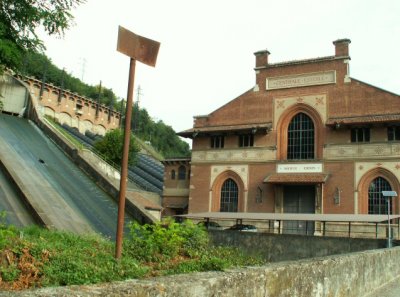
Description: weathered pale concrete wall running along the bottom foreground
xmin=6 ymin=243 xmax=400 ymax=297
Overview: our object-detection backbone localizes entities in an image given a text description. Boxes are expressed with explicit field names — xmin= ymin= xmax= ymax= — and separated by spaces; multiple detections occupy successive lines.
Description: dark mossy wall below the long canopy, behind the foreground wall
xmin=209 ymin=230 xmax=396 ymax=262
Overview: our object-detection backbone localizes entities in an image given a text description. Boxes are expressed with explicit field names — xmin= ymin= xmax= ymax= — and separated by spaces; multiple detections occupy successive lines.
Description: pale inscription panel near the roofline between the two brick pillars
xmin=266 ymin=70 xmax=336 ymax=90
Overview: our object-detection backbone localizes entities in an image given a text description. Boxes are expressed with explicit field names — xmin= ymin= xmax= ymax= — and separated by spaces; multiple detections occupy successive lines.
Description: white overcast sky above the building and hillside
xmin=42 ymin=0 xmax=400 ymax=131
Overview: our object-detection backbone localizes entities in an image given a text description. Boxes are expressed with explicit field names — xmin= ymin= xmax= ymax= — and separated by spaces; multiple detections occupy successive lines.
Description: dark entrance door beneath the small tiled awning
xmin=283 ymin=185 xmax=315 ymax=235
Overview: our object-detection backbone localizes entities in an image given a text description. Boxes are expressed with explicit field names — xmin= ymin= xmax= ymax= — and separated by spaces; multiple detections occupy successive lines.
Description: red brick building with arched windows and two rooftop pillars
xmin=173 ymin=39 xmax=400 ymax=227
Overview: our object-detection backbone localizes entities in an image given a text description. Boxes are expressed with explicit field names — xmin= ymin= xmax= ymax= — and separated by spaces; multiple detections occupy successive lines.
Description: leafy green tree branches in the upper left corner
xmin=0 ymin=0 xmax=86 ymax=71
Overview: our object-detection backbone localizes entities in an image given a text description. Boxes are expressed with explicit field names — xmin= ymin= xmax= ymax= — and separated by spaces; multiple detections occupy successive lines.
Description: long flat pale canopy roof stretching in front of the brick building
xmin=178 ymin=212 xmax=400 ymax=223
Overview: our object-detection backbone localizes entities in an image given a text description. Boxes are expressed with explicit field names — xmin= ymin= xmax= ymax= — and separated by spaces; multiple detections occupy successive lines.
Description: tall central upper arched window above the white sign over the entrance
xmin=287 ymin=112 xmax=314 ymax=160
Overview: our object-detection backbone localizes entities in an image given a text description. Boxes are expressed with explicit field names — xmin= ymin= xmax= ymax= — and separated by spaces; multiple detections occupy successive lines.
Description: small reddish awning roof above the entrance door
xmin=264 ymin=173 xmax=328 ymax=184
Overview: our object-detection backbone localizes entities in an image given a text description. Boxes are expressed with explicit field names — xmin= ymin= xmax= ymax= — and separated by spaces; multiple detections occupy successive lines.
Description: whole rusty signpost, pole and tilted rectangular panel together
xmin=115 ymin=26 xmax=160 ymax=259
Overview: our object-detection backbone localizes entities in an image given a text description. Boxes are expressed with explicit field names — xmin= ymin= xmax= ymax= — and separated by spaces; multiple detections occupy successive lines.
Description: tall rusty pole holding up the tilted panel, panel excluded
xmin=115 ymin=58 xmax=136 ymax=259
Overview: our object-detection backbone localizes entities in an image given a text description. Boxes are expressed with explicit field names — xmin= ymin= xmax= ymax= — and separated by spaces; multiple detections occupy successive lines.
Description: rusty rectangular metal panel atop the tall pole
xmin=117 ymin=26 xmax=160 ymax=67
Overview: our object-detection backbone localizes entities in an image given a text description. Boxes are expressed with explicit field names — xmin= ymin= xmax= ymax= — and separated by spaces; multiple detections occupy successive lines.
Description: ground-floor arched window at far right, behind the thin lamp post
xmin=368 ymin=176 xmax=393 ymax=214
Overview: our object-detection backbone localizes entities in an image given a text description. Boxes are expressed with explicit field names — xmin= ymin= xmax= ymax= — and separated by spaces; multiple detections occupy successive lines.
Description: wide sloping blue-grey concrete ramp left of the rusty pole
xmin=0 ymin=114 xmax=132 ymax=237
